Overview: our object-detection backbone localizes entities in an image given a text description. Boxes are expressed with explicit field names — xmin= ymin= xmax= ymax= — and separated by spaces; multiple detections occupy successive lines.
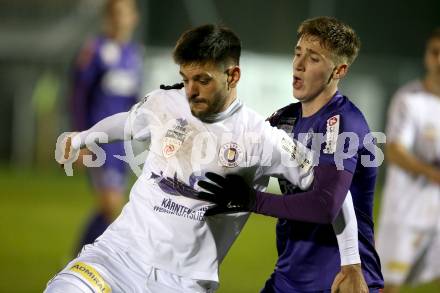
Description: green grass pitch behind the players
xmin=0 ymin=168 xmax=440 ymax=293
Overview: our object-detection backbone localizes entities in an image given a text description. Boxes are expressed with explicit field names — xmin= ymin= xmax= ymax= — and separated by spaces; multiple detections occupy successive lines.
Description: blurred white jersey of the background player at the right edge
xmin=381 ymin=81 xmax=440 ymax=229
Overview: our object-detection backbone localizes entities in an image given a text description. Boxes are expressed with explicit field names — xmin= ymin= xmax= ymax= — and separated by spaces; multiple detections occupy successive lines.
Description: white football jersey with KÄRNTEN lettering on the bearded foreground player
xmin=69 ymin=89 xmax=359 ymax=291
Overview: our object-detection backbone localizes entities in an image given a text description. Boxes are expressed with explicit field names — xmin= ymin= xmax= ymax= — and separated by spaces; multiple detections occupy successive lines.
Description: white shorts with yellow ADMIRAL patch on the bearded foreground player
xmin=44 ymin=245 xmax=217 ymax=293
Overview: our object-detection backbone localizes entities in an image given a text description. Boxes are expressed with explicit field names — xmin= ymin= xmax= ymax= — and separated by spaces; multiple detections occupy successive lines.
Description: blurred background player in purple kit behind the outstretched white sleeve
xmin=71 ymin=0 xmax=143 ymax=251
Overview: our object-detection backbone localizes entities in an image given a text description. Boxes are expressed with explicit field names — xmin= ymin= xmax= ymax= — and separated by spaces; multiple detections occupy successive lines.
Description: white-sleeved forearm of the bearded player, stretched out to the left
xmin=72 ymin=112 xmax=131 ymax=149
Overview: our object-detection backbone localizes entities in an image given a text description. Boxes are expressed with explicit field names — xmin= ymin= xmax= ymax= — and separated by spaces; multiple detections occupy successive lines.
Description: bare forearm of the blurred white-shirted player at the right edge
xmin=386 ymin=143 xmax=439 ymax=177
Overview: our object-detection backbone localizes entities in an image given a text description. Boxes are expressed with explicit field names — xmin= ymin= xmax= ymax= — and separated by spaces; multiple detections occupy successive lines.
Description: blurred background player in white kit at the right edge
xmin=377 ymin=28 xmax=440 ymax=293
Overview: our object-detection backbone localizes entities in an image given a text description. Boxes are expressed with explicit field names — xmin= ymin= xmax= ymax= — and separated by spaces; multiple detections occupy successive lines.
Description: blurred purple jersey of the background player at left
xmin=70 ymin=36 xmax=143 ymax=171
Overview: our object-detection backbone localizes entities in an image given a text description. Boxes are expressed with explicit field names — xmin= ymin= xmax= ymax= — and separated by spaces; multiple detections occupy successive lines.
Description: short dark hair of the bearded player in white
xmin=173 ymin=24 xmax=241 ymax=65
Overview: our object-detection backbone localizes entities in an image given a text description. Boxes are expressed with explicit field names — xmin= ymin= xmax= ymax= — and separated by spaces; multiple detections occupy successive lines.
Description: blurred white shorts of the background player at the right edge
xmin=376 ymin=223 xmax=440 ymax=285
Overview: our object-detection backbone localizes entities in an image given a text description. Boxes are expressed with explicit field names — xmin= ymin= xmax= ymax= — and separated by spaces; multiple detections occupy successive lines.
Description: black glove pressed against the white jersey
xmin=198 ymin=172 xmax=256 ymax=216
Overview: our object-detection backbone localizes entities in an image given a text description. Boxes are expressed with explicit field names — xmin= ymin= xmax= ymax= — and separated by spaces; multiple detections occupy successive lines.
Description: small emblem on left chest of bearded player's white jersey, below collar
xmin=162 ymin=118 xmax=189 ymax=158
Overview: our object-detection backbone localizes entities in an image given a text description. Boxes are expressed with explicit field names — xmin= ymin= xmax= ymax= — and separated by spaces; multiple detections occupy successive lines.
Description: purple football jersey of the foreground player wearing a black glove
xmin=263 ymin=92 xmax=383 ymax=292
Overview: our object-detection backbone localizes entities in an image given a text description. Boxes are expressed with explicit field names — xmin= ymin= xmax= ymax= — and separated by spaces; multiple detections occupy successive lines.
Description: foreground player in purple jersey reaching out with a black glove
xmin=200 ymin=17 xmax=383 ymax=293
